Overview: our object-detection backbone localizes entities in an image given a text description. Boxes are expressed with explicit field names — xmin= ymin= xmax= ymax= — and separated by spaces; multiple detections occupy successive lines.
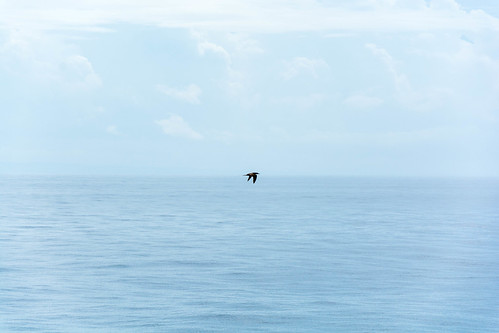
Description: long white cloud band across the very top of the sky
xmin=0 ymin=0 xmax=499 ymax=33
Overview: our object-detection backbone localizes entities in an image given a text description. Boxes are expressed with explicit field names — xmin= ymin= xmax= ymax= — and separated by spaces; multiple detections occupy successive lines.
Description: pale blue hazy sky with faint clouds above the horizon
xmin=0 ymin=0 xmax=499 ymax=177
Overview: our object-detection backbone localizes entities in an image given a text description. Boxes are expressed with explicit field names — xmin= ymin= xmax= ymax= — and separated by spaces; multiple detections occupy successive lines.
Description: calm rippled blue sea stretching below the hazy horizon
xmin=0 ymin=175 xmax=499 ymax=333
